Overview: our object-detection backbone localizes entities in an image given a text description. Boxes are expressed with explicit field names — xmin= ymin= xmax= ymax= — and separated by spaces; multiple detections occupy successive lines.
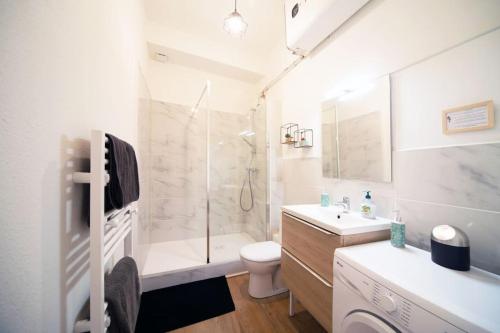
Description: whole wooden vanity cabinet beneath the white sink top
xmin=281 ymin=212 xmax=390 ymax=332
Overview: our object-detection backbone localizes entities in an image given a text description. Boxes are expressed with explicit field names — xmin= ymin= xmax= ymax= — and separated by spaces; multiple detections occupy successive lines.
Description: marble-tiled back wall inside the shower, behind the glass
xmin=143 ymin=101 xmax=266 ymax=242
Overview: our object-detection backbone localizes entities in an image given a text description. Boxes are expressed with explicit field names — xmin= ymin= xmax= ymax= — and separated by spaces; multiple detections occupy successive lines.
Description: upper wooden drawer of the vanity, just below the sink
xmin=282 ymin=213 xmax=342 ymax=284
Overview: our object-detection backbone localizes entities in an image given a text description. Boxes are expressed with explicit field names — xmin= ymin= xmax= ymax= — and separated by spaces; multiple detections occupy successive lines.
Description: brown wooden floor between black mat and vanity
xmin=173 ymin=274 xmax=326 ymax=333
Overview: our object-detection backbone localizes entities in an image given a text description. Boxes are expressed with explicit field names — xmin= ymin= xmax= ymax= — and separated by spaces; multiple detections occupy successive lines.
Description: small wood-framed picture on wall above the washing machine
xmin=442 ymin=101 xmax=495 ymax=134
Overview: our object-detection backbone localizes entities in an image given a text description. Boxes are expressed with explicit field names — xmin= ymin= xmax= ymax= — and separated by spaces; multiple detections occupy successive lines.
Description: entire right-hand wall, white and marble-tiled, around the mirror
xmin=262 ymin=0 xmax=500 ymax=273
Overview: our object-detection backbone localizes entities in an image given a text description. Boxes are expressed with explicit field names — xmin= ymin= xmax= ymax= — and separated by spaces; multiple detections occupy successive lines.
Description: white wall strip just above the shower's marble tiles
xmin=146 ymin=61 xmax=258 ymax=114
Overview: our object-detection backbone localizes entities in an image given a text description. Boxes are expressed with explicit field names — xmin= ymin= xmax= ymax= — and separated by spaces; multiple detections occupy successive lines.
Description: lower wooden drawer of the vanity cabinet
xmin=281 ymin=248 xmax=333 ymax=332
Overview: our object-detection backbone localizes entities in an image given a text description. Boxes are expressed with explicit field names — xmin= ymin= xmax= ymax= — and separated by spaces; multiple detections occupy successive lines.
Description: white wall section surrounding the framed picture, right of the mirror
xmin=391 ymin=29 xmax=500 ymax=150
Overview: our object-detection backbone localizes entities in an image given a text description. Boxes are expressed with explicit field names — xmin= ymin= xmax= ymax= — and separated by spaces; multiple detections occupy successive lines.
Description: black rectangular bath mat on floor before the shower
xmin=135 ymin=276 xmax=234 ymax=333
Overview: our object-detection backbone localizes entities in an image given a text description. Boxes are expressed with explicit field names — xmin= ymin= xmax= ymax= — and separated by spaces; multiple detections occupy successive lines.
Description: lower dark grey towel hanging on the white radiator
xmin=104 ymin=257 xmax=141 ymax=333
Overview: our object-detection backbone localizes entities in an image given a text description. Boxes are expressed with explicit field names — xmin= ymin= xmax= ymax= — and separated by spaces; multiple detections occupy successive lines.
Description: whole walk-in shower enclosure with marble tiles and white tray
xmin=139 ymin=83 xmax=268 ymax=277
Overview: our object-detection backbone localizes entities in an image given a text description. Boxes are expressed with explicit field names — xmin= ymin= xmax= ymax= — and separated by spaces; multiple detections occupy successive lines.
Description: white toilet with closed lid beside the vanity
xmin=240 ymin=241 xmax=288 ymax=298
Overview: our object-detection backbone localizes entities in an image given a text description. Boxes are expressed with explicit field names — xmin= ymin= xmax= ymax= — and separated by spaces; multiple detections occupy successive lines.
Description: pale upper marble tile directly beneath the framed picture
xmin=395 ymin=143 xmax=500 ymax=211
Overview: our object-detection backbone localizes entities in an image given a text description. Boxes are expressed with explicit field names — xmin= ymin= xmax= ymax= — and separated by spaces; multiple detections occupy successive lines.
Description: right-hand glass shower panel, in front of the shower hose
xmin=208 ymin=101 xmax=267 ymax=262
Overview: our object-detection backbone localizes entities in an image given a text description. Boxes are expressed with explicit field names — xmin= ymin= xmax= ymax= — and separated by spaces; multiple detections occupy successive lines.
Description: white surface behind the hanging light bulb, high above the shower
xmin=144 ymin=0 xmax=285 ymax=56
